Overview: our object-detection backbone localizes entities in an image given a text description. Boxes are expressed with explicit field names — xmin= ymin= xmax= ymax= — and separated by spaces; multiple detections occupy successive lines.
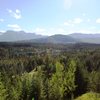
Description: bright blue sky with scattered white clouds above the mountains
xmin=0 ymin=0 xmax=100 ymax=35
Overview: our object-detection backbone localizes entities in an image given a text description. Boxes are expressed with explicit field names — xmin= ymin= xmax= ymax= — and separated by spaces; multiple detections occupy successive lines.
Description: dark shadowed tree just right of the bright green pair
xmin=74 ymin=59 xmax=89 ymax=96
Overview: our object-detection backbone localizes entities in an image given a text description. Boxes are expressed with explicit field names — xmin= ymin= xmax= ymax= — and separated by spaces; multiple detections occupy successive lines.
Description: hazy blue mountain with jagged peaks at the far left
xmin=0 ymin=30 xmax=44 ymax=42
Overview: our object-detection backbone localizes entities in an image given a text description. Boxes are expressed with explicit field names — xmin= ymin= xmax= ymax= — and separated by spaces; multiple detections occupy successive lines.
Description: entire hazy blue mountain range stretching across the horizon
xmin=0 ymin=31 xmax=100 ymax=44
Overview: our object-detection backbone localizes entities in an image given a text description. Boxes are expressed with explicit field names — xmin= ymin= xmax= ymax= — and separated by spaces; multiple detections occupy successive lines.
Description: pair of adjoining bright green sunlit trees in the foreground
xmin=50 ymin=60 xmax=76 ymax=100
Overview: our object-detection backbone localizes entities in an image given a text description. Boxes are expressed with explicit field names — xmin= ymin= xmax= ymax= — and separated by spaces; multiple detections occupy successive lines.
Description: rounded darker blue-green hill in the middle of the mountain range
xmin=29 ymin=34 xmax=78 ymax=44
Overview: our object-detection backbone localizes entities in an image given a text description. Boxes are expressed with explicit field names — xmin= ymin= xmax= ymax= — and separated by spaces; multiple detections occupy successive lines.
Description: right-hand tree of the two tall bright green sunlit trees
xmin=63 ymin=59 xmax=76 ymax=98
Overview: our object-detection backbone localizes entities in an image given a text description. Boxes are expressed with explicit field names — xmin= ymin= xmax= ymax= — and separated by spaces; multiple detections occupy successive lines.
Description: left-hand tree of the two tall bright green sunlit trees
xmin=49 ymin=62 xmax=64 ymax=100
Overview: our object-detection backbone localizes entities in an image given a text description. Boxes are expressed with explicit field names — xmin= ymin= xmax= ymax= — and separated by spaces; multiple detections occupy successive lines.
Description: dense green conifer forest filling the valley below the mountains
xmin=0 ymin=43 xmax=100 ymax=100
